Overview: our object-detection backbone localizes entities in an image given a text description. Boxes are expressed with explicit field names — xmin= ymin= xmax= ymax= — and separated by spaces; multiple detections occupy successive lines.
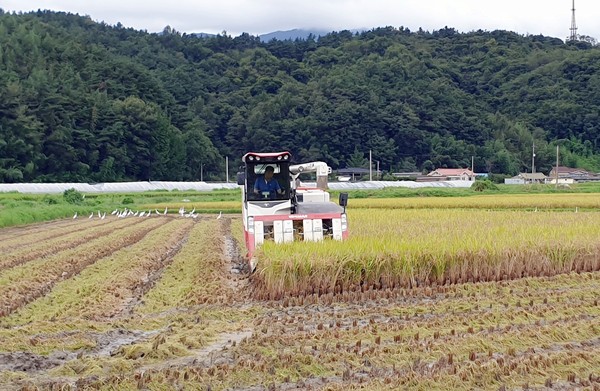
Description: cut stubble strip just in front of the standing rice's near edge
xmin=254 ymin=274 xmax=600 ymax=343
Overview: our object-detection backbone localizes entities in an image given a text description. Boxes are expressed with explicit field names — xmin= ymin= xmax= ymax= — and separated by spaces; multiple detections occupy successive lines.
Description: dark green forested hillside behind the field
xmin=0 ymin=10 xmax=600 ymax=182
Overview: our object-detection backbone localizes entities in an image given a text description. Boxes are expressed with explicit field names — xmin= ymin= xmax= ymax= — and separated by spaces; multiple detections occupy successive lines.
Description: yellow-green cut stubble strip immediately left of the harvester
xmin=106 ymin=218 xmax=256 ymax=363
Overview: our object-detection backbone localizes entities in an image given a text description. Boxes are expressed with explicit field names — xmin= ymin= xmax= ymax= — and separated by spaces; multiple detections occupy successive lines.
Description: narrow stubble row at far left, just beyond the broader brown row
xmin=0 ymin=220 xmax=150 ymax=273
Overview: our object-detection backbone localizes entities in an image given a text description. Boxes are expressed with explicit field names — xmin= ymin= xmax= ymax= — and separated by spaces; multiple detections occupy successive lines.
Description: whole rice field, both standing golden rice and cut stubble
xmin=0 ymin=194 xmax=600 ymax=390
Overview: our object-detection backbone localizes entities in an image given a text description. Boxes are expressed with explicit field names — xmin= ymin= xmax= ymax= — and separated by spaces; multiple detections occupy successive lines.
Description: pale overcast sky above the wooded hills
xmin=0 ymin=0 xmax=600 ymax=40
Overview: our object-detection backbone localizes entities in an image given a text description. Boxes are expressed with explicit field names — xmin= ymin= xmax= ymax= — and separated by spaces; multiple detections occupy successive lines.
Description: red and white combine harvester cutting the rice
xmin=237 ymin=152 xmax=348 ymax=271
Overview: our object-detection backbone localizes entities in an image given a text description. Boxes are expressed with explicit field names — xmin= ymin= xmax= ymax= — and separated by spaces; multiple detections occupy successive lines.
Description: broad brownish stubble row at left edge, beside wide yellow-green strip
xmin=0 ymin=219 xmax=168 ymax=317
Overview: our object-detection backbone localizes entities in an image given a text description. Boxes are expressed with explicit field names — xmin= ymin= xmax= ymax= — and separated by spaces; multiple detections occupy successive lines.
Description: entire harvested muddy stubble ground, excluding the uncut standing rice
xmin=0 ymin=215 xmax=600 ymax=390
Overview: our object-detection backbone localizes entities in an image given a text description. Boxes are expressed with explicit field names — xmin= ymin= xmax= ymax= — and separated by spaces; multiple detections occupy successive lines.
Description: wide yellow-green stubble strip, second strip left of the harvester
xmin=7 ymin=219 xmax=194 ymax=324
